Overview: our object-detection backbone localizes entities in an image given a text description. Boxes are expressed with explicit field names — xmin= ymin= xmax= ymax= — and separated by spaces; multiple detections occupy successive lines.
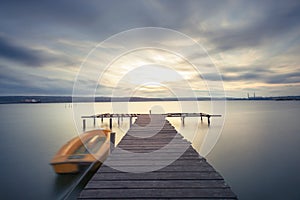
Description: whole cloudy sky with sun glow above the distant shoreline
xmin=0 ymin=0 xmax=300 ymax=97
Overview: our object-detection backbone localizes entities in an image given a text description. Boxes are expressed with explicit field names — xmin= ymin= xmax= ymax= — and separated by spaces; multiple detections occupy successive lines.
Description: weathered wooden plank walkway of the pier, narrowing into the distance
xmin=78 ymin=115 xmax=237 ymax=199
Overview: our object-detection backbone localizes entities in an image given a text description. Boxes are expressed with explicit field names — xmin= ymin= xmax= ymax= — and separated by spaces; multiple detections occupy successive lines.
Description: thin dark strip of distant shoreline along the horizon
xmin=0 ymin=96 xmax=300 ymax=104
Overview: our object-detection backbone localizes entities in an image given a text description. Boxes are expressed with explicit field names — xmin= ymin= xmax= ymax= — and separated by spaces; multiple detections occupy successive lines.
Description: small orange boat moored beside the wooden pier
xmin=50 ymin=130 xmax=110 ymax=174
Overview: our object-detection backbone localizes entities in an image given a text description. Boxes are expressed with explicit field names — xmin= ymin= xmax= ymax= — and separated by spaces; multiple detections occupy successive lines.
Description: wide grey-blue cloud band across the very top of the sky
xmin=0 ymin=0 xmax=300 ymax=51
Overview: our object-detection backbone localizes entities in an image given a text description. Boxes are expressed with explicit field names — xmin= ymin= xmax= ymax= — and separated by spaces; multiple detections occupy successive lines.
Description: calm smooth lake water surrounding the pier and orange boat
xmin=0 ymin=101 xmax=300 ymax=200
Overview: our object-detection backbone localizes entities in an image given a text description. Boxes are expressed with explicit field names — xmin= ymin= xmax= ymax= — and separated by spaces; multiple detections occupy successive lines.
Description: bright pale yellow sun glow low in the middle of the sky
xmin=99 ymin=49 xmax=206 ymax=96
